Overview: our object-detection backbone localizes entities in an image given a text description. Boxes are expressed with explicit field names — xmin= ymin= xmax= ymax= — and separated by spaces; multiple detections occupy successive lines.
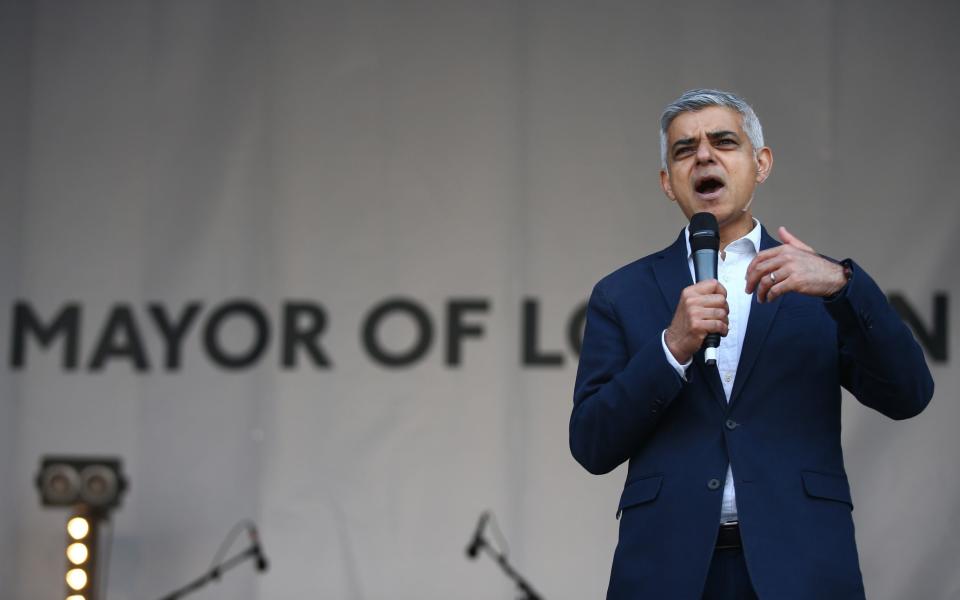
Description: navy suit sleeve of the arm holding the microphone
xmin=570 ymin=284 xmax=683 ymax=474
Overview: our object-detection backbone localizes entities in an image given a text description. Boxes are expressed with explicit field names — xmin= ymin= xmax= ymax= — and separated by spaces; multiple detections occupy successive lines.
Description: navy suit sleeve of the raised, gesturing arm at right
xmin=825 ymin=261 xmax=933 ymax=420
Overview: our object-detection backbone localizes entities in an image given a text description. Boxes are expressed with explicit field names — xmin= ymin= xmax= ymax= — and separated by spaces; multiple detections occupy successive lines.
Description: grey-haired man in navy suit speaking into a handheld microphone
xmin=570 ymin=90 xmax=933 ymax=600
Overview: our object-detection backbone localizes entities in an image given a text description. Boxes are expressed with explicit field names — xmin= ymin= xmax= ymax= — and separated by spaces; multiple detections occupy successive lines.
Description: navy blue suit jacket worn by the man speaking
xmin=570 ymin=230 xmax=933 ymax=600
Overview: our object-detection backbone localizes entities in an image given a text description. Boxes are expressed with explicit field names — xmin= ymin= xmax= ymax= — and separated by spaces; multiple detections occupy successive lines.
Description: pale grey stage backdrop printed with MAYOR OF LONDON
xmin=0 ymin=0 xmax=960 ymax=600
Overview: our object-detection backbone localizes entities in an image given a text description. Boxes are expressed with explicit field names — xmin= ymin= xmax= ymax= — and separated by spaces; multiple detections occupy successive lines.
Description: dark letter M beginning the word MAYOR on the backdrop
xmin=10 ymin=302 xmax=80 ymax=371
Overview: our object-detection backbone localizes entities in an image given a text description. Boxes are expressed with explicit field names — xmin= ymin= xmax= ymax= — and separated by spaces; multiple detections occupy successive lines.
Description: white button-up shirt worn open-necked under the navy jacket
xmin=660 ymin=219 xmax=760 ymax=523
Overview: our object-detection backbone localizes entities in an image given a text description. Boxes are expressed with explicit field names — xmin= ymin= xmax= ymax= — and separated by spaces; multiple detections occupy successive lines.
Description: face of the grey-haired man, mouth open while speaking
xmin=660 ymin=106 xmax=773 ymax=235
